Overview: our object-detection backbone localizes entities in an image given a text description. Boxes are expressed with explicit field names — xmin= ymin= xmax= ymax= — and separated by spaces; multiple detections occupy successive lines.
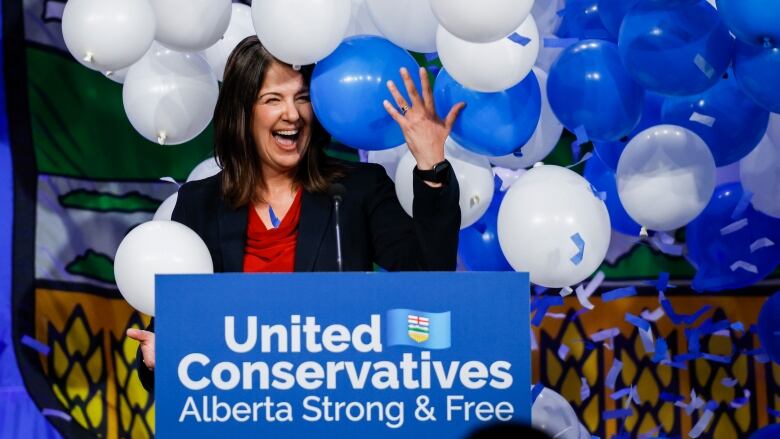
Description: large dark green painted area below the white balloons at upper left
xmin=27 ymin=46 xmax=213 ymax=181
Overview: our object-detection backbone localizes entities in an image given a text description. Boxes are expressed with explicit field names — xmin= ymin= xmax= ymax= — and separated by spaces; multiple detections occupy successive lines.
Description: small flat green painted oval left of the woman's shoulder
xmin=59 ymin=189 xmax=162 ymax=212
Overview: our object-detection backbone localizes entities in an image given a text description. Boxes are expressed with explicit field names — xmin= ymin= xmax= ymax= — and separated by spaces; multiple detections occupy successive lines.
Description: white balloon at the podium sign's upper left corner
xmin=114 ymin=221 xmax=214 ymax=316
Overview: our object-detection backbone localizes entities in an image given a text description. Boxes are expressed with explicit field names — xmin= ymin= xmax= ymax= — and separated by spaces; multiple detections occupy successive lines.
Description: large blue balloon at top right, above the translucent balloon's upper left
xmin=618 ymin=0 xmax=734 ymax=95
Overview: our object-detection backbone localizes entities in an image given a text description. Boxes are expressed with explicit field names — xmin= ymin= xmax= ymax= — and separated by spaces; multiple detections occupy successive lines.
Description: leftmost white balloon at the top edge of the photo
xmin=62 ymin=0 xmax=155 ymax=71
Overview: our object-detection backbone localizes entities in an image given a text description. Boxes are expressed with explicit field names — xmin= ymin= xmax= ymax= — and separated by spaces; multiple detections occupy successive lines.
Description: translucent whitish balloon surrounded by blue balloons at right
xmin=616 ymin=125 xmax=715 ymax=231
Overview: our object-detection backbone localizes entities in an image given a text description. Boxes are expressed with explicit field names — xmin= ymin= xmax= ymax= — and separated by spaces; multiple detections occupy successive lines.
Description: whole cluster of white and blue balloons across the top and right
xmin=93 ymin=0 xmax=780 ymax=306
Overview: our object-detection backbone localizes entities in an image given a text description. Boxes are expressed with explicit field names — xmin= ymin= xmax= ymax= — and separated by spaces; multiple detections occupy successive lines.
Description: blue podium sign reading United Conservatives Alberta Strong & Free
xmin=155 ymin=273 xmax=531 ymax=439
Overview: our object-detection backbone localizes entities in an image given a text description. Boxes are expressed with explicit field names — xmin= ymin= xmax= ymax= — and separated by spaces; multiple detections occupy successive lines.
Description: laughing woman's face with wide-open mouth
xmin=252 ymin=62 xmax=313 ymax=173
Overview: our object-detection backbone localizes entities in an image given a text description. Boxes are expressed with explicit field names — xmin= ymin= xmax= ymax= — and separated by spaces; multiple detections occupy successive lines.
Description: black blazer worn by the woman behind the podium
xmin=138 ymin=163 xmax=460 ymax=390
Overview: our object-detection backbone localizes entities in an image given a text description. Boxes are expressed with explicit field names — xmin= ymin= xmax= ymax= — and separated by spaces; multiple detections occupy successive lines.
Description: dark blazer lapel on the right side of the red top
xmin=295 ymin=191 xmax=336 ymax=271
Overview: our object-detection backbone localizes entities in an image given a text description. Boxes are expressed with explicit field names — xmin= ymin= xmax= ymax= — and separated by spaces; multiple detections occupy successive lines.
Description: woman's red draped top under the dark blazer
xmin=244 ymin=190 xmax=303 ymax=273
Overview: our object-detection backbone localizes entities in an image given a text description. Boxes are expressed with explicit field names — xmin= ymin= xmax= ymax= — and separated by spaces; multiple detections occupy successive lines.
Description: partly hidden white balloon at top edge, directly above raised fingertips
xmin=366 ymin=0 xmax=439 ymax=53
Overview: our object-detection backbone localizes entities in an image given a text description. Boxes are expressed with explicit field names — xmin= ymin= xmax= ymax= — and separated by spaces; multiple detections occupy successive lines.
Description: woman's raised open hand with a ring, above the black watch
xmin=383 ymin=67 xmax=466 ymax=171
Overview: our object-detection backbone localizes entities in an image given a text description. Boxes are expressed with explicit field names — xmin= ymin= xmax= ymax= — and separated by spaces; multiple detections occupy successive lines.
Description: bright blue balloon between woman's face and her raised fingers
xmin=311 ymin=36 xmax=421 ymax=150
